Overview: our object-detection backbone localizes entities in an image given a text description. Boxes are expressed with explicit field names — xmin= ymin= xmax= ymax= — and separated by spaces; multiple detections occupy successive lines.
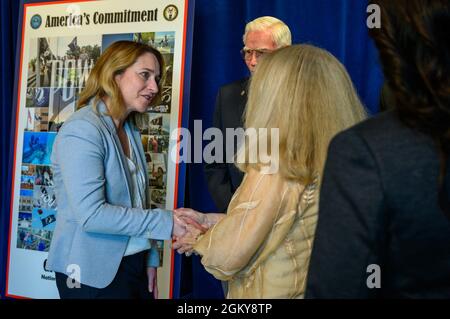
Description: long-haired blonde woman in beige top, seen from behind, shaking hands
xmin=174 ymin=45 xmax=366 ymax=298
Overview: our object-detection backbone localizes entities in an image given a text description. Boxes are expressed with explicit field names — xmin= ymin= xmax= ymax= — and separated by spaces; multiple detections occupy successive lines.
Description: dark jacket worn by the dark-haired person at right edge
xmin=306 ymin=111 xmax=450 ymax=298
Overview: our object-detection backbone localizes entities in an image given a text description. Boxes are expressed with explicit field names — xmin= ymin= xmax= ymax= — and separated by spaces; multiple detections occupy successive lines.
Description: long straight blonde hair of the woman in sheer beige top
xmin=236 ymin=45 xmax=367 ymax=184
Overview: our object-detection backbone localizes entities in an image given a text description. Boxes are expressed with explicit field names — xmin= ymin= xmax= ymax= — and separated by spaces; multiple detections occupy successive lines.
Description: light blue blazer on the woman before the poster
xmin=47 ymin=101 xmax=173 ymax=288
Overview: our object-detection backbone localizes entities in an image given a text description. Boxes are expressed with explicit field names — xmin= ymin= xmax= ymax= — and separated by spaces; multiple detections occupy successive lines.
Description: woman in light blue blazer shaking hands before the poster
xmin=47 ymin=41 xmax=185 ymax=298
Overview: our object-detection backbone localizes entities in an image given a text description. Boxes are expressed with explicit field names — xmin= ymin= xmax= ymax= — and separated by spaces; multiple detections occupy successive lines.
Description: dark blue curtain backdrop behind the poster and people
xmin=0 ymin=0 xmax=382 ymax=298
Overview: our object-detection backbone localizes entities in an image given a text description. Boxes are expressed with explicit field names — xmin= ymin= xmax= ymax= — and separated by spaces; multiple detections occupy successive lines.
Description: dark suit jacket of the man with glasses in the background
xmin=205 ymin=78 xmax=248 ymax=212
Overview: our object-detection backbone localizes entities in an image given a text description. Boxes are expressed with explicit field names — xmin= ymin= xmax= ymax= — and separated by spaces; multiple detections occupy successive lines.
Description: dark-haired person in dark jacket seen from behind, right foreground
xmin=306 ymin=0 xmax=450 ymax=298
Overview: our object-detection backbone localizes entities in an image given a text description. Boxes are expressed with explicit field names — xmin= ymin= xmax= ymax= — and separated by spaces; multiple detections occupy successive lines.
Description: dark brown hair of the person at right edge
xmin=369 ymin=0 xmax=450 ymax=179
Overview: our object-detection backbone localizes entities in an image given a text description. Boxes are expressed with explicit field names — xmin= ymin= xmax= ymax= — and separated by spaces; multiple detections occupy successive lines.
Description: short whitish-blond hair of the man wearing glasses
xmin=242 ymin=16 xmax=292 ymax=48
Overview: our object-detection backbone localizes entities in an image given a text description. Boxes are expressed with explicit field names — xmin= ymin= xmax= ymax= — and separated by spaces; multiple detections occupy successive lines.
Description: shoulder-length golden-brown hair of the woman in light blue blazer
xmin=78 ymin=41 xmax=164 ymax=125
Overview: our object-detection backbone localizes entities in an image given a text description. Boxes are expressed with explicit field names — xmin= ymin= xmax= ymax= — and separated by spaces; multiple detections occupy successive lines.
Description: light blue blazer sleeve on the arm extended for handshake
xmin=52 ymin=120 xmax=173 ymax=240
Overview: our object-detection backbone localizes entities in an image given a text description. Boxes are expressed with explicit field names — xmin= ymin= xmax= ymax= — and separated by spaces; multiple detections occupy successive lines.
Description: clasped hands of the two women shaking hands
xmin=172 ymin=208 xmax=225 ymax=256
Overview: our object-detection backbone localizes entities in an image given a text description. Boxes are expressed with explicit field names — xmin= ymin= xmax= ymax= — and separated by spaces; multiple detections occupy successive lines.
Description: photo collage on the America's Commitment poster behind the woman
xmin=17 ymin=32 xmax=175 ymax=260
